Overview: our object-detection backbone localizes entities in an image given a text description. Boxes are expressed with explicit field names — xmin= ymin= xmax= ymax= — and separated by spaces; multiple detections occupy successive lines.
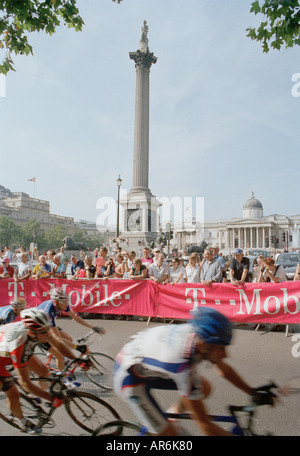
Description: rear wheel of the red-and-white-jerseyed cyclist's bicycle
xmin=0 ymin=391 xmax=39 ymax=430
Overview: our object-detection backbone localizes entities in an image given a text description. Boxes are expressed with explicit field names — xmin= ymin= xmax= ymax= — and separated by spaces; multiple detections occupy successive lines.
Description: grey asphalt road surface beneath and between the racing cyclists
xmin=0 ymin=319 xmax=300 ymax=437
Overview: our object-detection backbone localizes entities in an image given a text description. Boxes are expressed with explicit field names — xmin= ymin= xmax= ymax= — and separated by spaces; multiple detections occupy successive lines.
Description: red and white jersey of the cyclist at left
xmin=0 ymin=321 xmax=37 ymax=377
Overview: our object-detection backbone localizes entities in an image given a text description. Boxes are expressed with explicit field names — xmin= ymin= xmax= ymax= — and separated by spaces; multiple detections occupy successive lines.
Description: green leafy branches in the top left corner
xmin=0 ymin=0 xmax=122 ymax=74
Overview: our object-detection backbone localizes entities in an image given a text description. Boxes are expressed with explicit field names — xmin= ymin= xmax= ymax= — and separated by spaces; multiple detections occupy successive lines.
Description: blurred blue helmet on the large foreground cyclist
xmin=191 ymin=307 xmax=232 ymax=345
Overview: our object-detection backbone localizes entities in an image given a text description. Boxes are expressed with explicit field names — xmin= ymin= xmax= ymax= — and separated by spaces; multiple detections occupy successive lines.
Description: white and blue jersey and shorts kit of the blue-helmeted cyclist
xmin=113 ymin=324 xmax=203 ymax=433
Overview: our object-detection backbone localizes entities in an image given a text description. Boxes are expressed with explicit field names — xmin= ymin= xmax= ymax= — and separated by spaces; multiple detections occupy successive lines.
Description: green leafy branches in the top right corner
xmin=247 ymin=0 xmax=300 ymax=52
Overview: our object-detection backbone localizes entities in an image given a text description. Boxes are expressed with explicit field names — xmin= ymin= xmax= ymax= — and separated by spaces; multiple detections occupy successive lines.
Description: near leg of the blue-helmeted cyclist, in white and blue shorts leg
xmin=113 ymin=364 xmax=177 ymax=435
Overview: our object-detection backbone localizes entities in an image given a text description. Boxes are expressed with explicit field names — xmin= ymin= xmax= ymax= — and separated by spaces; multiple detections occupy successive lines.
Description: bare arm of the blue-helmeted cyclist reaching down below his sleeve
xmin=181 ymin=397 xmax=232 ymax=436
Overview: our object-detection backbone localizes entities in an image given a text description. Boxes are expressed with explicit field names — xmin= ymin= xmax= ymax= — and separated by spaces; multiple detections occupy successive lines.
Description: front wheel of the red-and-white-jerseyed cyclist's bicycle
xmin=64 ymin=391 xmax=120 ymax=435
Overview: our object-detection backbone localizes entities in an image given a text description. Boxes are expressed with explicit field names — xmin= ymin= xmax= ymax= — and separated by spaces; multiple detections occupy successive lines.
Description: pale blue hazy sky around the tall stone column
xmin=0 ymin=0 xmax=300 ymax=227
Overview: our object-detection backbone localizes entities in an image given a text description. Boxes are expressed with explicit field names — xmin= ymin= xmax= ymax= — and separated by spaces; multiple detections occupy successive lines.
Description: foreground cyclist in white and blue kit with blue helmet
xmin=113 ymin=307 xmax=274 ymax=436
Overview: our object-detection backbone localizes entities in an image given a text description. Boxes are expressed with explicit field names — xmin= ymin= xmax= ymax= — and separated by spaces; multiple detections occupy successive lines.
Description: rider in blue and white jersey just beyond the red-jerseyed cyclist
xmin=37 ymin=288 xmax=105 ymax=370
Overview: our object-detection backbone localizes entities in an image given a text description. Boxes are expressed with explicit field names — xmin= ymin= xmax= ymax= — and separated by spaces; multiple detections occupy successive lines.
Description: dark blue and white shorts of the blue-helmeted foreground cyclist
xmin=113 ymin=362 xmax=177 ymax=434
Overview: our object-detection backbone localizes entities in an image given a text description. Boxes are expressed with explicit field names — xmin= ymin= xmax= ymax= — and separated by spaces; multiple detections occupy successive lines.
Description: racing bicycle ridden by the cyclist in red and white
xmin=0 ymin=358 xmax=120 ymax=434
